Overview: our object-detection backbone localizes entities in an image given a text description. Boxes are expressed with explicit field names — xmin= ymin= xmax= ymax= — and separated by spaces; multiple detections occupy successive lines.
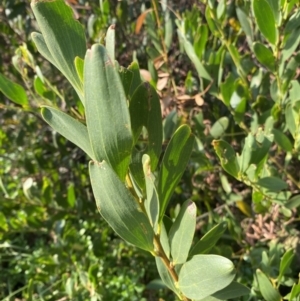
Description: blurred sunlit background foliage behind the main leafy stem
xmin=0 ymin=0 xmax=300 ymax=300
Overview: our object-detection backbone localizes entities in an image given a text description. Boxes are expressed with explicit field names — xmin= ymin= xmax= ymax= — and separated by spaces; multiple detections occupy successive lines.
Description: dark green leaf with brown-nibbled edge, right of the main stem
xmin=212 ymin=140 xmax=240 ymax=179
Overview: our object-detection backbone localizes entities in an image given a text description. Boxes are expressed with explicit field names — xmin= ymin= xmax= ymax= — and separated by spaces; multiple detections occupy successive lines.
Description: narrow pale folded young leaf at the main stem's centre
xmin=143 ymin=154 xmax=159 ymax=232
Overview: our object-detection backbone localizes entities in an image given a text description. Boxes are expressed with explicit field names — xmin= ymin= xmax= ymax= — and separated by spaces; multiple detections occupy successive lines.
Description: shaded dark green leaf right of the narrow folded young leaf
xmin=157 ymin=125 xmax=195 ymax=221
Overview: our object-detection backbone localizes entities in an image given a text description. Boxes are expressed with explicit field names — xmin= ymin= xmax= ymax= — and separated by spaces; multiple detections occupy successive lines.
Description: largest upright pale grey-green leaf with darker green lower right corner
xmin=84 ymin=44 xmax=132 ymax=181
